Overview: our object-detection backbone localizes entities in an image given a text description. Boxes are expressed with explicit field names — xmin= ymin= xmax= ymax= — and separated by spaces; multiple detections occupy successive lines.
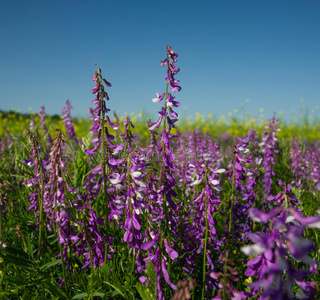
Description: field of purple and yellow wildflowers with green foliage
xmin=0 ymin=46 xmax=320 ymax=300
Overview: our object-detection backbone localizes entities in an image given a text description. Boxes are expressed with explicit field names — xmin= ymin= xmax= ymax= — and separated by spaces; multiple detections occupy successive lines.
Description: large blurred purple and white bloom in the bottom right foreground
xmin=242 ymin=208 xmax=318 ymax=299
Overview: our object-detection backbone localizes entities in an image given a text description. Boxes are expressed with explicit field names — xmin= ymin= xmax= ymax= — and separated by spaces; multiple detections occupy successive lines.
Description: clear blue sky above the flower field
xmin=0 ymin=0 xmax=320 ymax=118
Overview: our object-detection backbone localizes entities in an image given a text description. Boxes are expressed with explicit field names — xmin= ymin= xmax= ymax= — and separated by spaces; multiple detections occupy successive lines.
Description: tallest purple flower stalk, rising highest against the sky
xmin=141 ymin=46 xmax=181 ymax=299
